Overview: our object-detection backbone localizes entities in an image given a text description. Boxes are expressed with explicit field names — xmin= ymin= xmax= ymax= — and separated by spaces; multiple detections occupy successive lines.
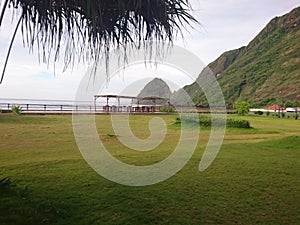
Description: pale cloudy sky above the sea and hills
xmin=0 ymin=0 xmax=300 ymax=100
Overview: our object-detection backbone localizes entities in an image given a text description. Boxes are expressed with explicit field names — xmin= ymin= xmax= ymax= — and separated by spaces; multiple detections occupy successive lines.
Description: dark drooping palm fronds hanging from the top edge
xmin=0 ymin=0 xmax=196 ymax=83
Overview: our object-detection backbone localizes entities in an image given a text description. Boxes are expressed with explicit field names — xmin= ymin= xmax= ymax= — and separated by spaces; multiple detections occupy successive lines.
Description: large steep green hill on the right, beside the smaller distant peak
xmin=172 ymin=7 xmax=300 ymax=107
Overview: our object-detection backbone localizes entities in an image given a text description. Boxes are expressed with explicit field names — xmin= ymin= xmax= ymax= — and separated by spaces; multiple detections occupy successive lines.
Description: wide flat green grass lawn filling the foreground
xmin=0 ymin=114 xmax=300 ymax=225
